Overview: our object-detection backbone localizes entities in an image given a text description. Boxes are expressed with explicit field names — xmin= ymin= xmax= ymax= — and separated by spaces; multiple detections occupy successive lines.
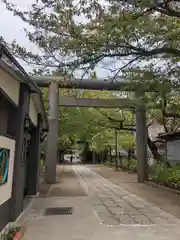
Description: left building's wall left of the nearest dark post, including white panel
xmin=0 ymin=68 xmax=20 ymax=231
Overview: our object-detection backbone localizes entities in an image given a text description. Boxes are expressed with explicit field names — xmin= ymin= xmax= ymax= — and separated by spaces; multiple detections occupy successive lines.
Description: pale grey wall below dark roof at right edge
xmin=166 ymin=139 xmax=180 ymax=162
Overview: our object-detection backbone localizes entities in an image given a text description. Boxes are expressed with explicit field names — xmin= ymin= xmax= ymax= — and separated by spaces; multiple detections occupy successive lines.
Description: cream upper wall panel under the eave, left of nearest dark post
xmin=0 ymin=68 xmax=20 ymax=106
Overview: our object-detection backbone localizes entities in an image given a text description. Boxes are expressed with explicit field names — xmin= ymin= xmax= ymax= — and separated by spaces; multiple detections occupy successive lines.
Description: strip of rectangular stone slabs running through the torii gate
xmin=74 ymin=166 xmax=180 ymax=225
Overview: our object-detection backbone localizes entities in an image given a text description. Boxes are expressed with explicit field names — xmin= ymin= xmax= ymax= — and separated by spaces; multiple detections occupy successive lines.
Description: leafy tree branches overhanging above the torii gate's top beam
xmin=0 ymin=0 xmax=180 ymax=78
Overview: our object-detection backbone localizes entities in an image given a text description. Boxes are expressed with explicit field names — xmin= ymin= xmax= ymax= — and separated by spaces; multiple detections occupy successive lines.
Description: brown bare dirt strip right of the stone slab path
xmin=91 ymin=166 xmax=180 ymax=218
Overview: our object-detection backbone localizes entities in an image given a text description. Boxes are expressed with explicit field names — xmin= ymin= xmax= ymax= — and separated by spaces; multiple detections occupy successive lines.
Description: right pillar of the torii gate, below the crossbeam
xmin=136 ymin=94 xmax=148 ymax=183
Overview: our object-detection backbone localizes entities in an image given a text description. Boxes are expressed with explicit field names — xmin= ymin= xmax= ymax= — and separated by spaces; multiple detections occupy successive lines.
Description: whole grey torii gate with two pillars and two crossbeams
xmin=31 ymin=76 xmax=150 ymax=184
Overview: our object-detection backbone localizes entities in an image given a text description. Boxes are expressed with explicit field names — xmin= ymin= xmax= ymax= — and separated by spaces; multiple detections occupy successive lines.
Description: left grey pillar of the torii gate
xmin=44 ymin=81 xmax=59 ymax=184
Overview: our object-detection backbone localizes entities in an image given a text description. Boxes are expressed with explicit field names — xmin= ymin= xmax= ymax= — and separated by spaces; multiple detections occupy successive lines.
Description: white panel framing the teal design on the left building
xmin=0 ymin=136 xmax=15 ymax=205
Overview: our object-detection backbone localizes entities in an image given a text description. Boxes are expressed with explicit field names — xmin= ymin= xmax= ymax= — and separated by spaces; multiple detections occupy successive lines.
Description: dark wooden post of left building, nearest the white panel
xmin=9 ymin=83 xmax=30 ymax=222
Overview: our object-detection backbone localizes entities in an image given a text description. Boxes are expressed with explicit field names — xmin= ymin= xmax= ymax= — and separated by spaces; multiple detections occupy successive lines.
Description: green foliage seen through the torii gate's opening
xmin=44 ymin=89 xmax=135 ymax=152
